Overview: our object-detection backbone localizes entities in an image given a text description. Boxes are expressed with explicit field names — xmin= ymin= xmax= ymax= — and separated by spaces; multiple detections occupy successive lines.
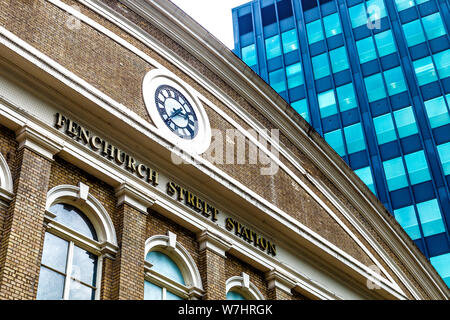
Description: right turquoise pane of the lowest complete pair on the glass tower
xmin=417 ymin=199 xmax=445 ymax=237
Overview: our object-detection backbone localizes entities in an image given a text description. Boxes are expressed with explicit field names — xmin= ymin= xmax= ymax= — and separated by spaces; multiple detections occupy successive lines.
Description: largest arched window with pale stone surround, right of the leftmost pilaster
xmin=36 ymin=184 xmax=117 ymax=300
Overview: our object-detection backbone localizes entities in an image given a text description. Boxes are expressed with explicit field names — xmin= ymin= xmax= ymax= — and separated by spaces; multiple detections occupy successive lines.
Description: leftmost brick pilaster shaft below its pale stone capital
xmin=0 ymin=145 xmax=51 ymax=299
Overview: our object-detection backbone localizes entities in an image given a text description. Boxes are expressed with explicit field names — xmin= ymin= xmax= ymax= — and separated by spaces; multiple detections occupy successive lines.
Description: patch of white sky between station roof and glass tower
xmin=170 ymin=0 xmax=251 ymax=49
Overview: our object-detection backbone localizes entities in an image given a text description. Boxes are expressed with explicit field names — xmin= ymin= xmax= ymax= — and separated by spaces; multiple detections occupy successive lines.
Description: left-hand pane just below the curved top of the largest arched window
xmin=41 ymin=232 xmax=69 ymax=273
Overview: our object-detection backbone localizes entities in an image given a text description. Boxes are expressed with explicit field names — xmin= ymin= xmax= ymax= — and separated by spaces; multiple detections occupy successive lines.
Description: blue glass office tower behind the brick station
xmin=233 ymin=0 xmax=450 ymax=285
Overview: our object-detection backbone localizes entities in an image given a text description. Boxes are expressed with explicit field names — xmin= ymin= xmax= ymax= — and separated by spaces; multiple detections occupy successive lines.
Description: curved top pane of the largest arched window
xmin=49 ymin=203 xmax=97 ymax=240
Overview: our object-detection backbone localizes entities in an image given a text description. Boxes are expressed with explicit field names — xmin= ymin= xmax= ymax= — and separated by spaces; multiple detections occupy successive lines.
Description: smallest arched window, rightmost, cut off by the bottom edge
xmin=226 ymin=272 xmax=264 ymax=300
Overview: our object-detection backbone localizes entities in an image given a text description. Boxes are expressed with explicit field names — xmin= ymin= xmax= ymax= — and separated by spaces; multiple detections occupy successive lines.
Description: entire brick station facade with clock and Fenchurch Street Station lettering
xmin=0 ymin=0 xmax=449 ymax=300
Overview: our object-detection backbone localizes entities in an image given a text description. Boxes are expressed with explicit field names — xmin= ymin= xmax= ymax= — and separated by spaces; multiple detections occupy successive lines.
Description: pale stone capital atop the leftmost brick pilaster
xmin=16 ymin=124 xmax=63 ymax=161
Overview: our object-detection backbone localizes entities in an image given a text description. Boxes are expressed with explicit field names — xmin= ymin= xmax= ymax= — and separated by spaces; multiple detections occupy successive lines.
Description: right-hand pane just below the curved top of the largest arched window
xmin=71 ymin=246 xmax=98 ymax=287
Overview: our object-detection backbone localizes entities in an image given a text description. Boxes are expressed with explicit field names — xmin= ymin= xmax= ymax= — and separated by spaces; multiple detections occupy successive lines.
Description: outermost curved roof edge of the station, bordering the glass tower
xmin=116 ymin=0 xmax=450 ymax=299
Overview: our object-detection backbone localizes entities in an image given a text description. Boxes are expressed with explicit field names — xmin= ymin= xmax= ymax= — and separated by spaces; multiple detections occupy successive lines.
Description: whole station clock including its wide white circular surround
xmin=142 ymin=70 xmax=211 ymax=154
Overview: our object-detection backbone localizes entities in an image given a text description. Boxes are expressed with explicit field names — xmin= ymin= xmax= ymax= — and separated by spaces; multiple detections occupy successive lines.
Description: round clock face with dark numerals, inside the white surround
xmin=155 ymin=85 xmax=198 ymax=140
